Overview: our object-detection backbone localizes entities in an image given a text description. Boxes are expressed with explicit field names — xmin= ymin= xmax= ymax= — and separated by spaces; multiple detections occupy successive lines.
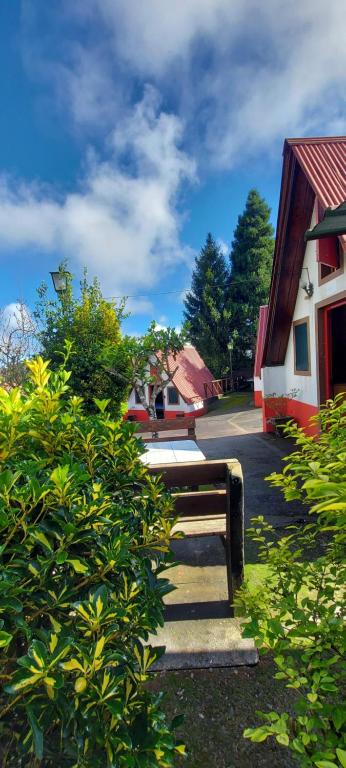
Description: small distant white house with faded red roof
xmin=127 ymin=344 xmax=214 ymax=421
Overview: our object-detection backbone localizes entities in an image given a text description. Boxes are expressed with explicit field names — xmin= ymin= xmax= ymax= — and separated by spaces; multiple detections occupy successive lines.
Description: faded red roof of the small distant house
xmin=169 ymin=345 xmax=214 ymax=403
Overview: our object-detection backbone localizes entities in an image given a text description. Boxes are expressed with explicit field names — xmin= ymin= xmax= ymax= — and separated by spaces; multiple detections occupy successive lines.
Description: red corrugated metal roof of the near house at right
xmin=286 ymin=136 xmax=346 ymax=243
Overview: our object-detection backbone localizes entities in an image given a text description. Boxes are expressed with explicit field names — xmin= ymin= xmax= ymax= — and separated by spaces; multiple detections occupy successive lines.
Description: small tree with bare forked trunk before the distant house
xmin=103 ymin=321 xmax=184 ymax=419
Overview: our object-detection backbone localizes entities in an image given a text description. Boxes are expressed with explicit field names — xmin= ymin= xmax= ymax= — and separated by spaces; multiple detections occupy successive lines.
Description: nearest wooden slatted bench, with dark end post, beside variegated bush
xmin=150 ymin=459 xmax=244 ymax=615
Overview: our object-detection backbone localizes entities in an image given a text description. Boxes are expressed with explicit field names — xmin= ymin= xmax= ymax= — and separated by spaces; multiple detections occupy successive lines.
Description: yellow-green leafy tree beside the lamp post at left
xmin=36 ymin=264 xmax=128 ymax=413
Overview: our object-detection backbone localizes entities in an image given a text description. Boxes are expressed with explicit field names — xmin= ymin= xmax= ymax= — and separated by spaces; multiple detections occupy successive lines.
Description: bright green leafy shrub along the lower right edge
xmin=239 ymin=398 xmax=346 ymax=768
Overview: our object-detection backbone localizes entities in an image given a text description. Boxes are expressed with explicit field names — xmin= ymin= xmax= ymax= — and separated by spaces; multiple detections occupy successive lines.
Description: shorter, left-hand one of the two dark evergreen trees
xmin=184 ymin=233 xmax=230 ymax=378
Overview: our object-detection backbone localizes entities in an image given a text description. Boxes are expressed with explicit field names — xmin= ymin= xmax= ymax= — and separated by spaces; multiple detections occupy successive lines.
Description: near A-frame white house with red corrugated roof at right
xmin=255 ymin=136 xmax=346 ymax=431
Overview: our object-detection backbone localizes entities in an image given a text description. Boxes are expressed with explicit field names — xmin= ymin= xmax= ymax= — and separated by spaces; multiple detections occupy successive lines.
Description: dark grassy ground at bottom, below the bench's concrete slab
xmin=150 ymin=656 xmax=296 ymax=768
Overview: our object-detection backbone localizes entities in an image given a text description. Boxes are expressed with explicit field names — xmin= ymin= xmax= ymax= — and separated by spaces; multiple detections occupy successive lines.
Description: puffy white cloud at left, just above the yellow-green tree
xmin=0 ymin=89 xmax=195 ymax=304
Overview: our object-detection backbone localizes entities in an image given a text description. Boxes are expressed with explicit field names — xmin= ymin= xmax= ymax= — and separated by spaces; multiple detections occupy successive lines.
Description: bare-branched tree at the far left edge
xmin=0 ymin=301 xmax=37 ymax=387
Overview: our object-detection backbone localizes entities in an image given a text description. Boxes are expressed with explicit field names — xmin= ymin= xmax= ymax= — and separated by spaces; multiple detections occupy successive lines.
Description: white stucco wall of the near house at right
xmin=262 ymin=201 xmax=346 ymax=406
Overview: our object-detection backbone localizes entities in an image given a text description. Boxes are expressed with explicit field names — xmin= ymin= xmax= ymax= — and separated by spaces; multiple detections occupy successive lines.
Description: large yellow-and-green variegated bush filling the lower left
xmin=0 ymin=358 xmax=184 ymax=768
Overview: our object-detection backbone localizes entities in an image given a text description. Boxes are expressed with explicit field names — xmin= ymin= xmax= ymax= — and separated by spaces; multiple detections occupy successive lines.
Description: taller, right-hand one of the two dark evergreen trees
xmin=229 ymin=189 xmax=274 ymax=368
